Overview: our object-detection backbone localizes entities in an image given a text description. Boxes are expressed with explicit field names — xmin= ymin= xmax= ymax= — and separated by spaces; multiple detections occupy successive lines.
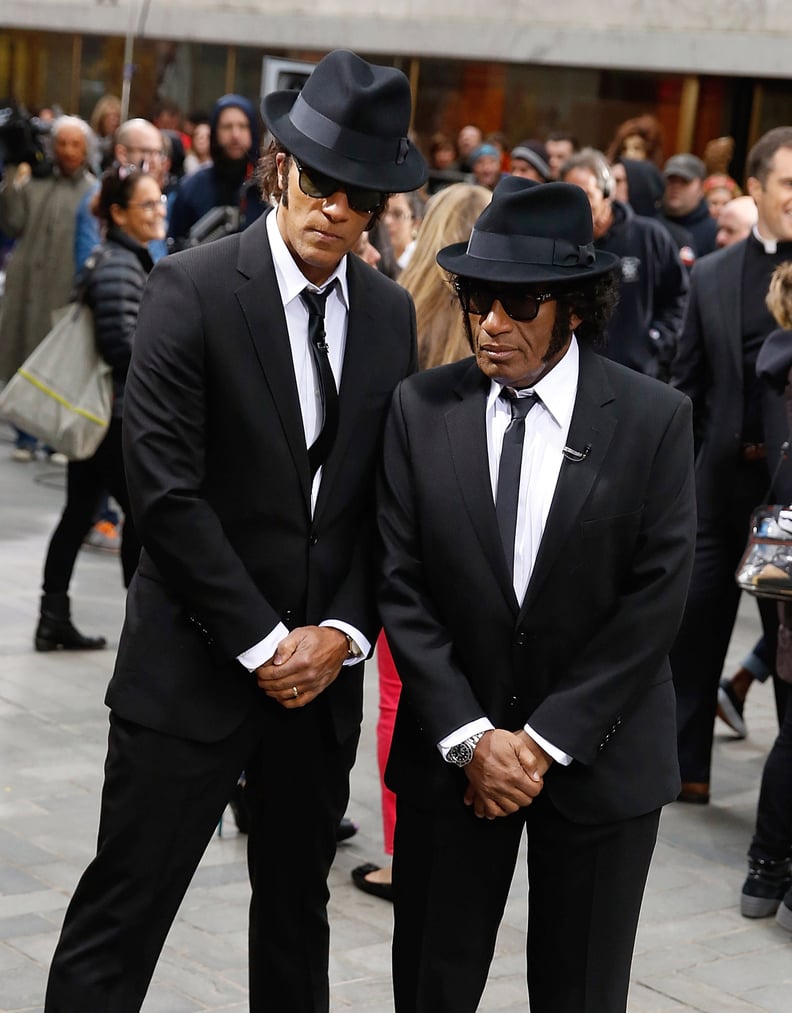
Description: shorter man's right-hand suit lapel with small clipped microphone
xmin=520 ymin=344 xmax=617 ymax=614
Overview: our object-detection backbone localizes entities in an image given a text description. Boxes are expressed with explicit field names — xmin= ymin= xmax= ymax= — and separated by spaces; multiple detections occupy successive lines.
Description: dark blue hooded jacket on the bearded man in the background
xmin=168 ymin=94 xmax=265 ymax=247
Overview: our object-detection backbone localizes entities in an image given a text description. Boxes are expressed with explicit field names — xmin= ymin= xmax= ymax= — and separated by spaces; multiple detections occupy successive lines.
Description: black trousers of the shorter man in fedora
xmin=393 ymin=794 xmax=659 ymax=1013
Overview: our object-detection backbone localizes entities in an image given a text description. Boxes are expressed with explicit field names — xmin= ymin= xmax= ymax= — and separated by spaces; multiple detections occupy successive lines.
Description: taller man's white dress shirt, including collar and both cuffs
xmin=237 ymin=211 xmax=371 ymax=672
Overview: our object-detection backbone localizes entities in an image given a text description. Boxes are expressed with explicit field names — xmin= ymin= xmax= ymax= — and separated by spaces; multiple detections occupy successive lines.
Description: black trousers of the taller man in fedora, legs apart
xmin=45 ymin=706 xmax=358 ymax=1013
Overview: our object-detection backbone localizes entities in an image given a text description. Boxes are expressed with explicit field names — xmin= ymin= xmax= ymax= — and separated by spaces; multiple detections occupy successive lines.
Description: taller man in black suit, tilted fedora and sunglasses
xmin=46 ymin=52 xmax=426 ymax=1013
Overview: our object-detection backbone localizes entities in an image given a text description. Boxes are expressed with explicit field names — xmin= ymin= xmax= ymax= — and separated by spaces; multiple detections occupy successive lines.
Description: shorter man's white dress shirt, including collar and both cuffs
xmin=438 ymin=336 xmax=580 ymax=766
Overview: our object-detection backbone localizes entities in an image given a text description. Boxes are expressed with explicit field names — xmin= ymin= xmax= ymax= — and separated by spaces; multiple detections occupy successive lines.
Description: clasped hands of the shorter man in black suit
xmin=465 ymin=728 xmax=553 ymax=820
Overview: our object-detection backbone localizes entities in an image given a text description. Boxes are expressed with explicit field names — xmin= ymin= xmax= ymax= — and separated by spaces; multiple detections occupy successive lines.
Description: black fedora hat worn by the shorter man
xmin=438 ymin=176 xmax=619 ymax=285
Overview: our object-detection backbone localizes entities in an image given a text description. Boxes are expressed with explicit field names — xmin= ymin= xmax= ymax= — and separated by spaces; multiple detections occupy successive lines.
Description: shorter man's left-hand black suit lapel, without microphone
xmin=446 ymin=360 xmax=518 ymax=613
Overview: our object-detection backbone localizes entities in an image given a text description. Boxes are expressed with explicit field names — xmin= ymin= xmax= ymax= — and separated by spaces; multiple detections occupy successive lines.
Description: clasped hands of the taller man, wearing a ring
xmin=253 ymin=626 xmax=348 ymax=710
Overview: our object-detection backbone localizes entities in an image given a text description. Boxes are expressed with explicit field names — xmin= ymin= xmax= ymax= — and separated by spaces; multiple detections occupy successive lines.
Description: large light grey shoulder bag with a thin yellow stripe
xmin=0 ymin=255 xmax=112 ymax=461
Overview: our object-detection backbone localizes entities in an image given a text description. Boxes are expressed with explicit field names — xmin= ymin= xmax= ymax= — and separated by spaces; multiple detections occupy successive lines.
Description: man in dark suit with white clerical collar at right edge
xmin=671 ymin=127 xmax=792 ymax=803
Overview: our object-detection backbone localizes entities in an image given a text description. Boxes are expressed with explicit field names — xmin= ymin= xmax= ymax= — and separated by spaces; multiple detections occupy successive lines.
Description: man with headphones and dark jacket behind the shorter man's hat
xmin=561 ymin=148 xmax=688 ymax=380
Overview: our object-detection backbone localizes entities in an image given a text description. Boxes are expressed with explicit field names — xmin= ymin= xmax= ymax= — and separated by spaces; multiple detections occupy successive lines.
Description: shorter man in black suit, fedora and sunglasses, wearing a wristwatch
xmin=379 ymin=177 xmax=695 ymax=1013
